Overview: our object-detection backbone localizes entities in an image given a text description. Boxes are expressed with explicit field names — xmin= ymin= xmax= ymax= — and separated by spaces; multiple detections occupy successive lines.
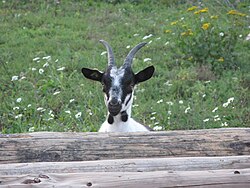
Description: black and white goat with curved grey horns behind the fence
xmin=82 ymin=40 xmax=154 ymax=132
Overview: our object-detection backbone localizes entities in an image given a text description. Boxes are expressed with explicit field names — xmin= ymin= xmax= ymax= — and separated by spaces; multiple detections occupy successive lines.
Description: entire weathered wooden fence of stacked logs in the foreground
xmin=0 ymin=128 xmax=250 ymax=188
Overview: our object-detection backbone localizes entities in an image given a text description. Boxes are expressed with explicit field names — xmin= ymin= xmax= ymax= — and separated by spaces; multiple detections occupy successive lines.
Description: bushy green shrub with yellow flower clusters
xmin=165 ymin=6 xmax=247 ymax=74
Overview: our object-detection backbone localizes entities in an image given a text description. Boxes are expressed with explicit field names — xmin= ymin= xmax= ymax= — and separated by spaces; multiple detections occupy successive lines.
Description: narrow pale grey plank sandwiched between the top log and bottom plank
xmin=0 ymin=155 xmax=250 ymax=176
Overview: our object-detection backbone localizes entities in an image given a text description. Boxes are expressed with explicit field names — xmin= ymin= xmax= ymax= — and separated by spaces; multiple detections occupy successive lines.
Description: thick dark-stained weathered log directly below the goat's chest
xmin=0 ymin=128 xmax=250 ymax=163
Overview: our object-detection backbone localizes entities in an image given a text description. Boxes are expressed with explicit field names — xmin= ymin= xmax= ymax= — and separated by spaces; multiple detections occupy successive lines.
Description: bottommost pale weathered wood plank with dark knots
xmin=0 ymin=168 xmax=250 ymax=188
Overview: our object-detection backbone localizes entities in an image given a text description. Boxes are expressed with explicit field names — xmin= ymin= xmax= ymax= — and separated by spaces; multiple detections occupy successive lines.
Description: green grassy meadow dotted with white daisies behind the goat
xmin=0 ymin=0 xmax=250 ymax=134
